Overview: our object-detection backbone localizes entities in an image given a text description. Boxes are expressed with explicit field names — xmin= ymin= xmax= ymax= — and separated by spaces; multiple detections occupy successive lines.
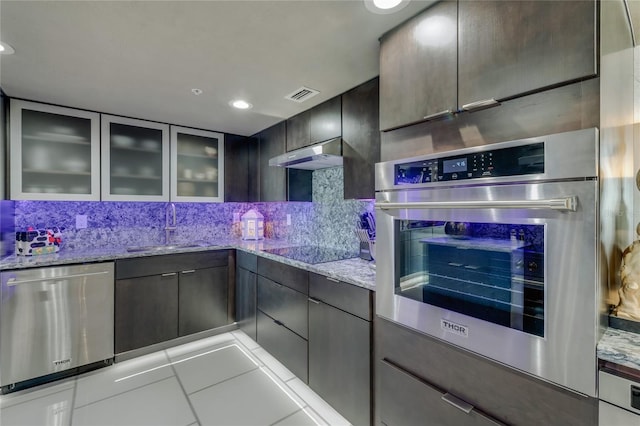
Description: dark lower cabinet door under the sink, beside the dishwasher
xmin=115 ymin=273 xmax=178 ymax=353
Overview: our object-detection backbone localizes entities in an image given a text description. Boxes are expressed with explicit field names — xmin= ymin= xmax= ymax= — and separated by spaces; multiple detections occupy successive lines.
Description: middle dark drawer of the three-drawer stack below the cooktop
xmin=258 ymin=276 xmax=309 ymax=339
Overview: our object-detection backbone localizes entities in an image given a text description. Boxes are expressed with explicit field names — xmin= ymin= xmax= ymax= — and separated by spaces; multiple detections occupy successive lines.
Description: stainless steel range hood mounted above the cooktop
xmin=269 ymin=138 xmax=342 ymax=170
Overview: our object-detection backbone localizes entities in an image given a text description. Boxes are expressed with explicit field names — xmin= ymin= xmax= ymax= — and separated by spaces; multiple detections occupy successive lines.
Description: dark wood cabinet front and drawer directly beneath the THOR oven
xmin=375 ymin=318 xmax=598 ymax=426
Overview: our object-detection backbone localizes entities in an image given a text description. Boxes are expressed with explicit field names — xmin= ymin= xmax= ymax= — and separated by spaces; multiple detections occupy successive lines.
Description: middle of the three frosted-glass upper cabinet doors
xmin=102 ymin=115 xmax=169 ymax=201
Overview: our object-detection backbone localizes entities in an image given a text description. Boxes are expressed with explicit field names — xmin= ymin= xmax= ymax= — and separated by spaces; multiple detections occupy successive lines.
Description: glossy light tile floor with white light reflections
xmin=0 ymin=330 xmax=349 ymax=426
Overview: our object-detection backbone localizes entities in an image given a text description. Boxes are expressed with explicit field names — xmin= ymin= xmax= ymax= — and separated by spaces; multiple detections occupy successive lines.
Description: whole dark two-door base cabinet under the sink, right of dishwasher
xmin=114 ymin=250 xmax=233 ymax=354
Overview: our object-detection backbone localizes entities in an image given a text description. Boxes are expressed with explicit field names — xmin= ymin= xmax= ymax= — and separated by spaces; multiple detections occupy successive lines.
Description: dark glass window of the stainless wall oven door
xmin=395 ymin=220 xmax=545 ymax=337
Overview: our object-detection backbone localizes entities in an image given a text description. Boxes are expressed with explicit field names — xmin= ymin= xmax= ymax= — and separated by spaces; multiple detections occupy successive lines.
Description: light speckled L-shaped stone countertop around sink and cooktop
xmin=0 ymin=239 xmax=376 ymax=291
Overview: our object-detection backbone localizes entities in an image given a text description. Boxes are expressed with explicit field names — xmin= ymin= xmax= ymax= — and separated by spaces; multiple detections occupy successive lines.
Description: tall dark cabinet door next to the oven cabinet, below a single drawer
xmin=309 ymin=300 xmax=371 ymax=426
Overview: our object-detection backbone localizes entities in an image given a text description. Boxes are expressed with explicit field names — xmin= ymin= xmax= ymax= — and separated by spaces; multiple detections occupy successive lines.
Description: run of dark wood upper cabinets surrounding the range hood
xmin=256 ymin=78 xmax=380 ymax=201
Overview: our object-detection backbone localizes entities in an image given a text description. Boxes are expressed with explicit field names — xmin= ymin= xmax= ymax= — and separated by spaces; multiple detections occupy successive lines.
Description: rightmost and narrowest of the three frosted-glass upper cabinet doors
xmin=171 ymin=126 xmax=224 ymax=202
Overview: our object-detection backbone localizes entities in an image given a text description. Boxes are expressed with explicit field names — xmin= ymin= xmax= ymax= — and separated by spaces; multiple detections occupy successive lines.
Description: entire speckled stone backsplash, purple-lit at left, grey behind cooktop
xmin=10 ymin=167 xmax=373 ymax=252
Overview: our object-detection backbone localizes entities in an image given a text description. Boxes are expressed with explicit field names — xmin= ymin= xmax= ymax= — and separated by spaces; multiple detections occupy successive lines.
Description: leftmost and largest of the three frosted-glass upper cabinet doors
xmin=10 ymin=99 xmax=100 ymax=201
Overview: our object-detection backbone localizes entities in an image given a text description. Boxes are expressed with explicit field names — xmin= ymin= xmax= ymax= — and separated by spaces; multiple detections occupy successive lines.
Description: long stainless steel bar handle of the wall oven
xmin=375 ymin=197 xmax=578 ymax=212
